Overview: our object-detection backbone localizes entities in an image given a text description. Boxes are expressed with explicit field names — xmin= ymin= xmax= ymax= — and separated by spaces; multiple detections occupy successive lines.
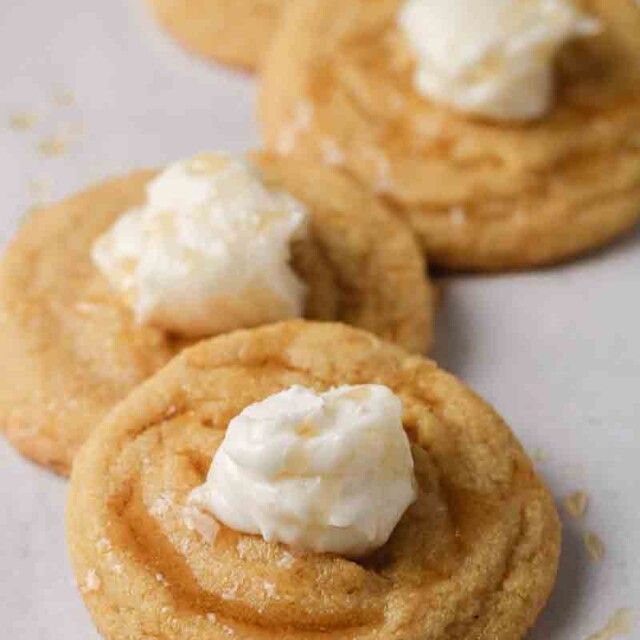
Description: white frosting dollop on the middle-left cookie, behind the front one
xmin=92 ymin=154 xmax=308 ymax=337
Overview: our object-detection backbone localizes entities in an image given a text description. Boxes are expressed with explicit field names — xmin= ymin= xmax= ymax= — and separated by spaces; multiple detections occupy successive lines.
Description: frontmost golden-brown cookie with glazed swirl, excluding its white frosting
xmin=67 ymin=321 xmax=560 ymax=640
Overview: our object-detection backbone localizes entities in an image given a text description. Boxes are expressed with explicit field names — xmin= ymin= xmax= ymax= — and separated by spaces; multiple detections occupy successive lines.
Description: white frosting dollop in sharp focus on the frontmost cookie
xmin=189 ymin=385 xmax=416 ymax=557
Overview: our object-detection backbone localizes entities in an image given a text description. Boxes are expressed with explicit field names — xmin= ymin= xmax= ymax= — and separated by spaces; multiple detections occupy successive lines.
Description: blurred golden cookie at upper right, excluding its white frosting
xmin=261 ymin=0 xmax=640 ymax=270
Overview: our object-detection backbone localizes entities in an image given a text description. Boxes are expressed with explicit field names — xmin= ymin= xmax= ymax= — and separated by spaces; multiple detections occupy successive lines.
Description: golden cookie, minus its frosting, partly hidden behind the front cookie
xmin=0 ymin=155 xmax=432 ymax=473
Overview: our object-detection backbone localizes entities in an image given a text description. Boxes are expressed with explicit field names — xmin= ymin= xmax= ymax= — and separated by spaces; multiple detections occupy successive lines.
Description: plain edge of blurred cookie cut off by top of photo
xmin=148 ymin=0 xmax=287 ymax=69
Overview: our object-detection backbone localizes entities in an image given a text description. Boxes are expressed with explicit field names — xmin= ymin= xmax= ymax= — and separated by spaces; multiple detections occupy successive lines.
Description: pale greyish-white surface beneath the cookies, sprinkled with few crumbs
xmin=0 ymin=0 xmax=640 ymax=640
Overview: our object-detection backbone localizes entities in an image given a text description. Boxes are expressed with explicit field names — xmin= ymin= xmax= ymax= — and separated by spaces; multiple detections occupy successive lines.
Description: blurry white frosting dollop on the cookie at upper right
xmin=398 ymin=0 xmax=600 ymax=120
